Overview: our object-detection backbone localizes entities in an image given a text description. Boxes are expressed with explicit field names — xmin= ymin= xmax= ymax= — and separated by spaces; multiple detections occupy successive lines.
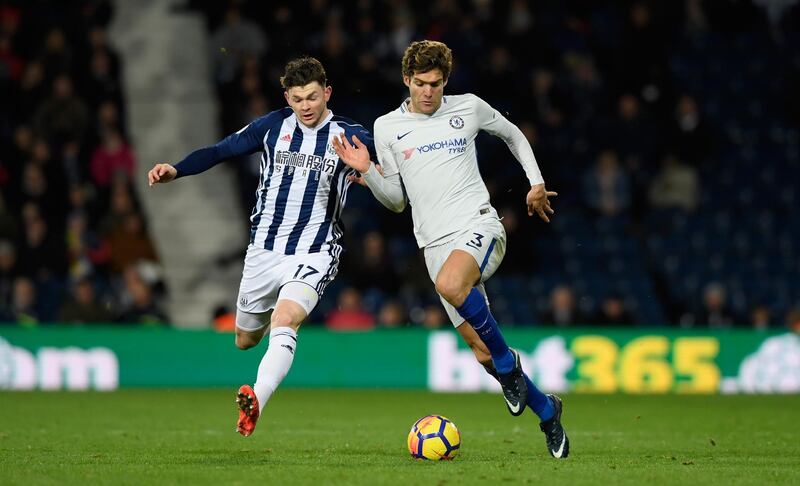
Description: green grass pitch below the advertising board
xmin=0 ymin=388 xmax=800 ymax=485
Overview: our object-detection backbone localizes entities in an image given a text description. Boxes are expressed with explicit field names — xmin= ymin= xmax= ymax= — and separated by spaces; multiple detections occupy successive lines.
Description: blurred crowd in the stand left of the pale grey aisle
xmin=0 ymin=1 xmax=168 ymax=326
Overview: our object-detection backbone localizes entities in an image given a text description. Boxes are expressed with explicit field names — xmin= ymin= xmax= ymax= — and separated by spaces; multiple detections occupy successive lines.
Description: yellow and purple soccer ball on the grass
xmin=408 ymin=415 xmax=461 ymax=461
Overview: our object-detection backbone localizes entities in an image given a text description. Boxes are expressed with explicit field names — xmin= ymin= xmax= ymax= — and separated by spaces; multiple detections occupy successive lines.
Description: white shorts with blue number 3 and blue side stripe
xmin=425 ymin=217 xmax=506 ymax=327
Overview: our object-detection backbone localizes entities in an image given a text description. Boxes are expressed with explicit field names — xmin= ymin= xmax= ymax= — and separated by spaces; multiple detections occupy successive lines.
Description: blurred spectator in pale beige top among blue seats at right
xmin=649 ymin=155 xmax=700 ymax=212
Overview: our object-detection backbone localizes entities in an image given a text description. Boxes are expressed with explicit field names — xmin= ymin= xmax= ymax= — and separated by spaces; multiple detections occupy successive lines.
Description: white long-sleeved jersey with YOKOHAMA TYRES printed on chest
xmin=373 ymin=94 xmax=544 ymax=248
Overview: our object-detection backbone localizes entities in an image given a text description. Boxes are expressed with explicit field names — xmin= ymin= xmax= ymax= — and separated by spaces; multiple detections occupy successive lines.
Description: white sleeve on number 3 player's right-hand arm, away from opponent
xmin=473 ymin=96 xmax=544 ymax=186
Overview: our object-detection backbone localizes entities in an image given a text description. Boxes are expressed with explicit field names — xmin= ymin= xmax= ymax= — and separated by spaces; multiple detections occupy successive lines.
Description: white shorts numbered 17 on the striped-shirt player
xmin=236 ymin=245 xmax=339 ymax=314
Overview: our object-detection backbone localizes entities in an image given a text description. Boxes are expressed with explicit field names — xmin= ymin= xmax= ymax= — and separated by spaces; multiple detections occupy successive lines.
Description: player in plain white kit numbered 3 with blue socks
xmin=334 ymin=41 xmax=569 ymax=458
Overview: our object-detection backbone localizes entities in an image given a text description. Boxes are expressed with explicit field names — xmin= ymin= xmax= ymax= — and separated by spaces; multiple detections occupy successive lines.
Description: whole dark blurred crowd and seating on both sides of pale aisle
xmin=0 ymin=0 xmax=800 ymax=329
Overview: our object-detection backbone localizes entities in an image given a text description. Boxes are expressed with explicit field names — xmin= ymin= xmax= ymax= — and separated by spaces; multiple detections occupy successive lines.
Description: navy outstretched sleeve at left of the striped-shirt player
xmin=175 ymin=112 xmax=279 ymax=177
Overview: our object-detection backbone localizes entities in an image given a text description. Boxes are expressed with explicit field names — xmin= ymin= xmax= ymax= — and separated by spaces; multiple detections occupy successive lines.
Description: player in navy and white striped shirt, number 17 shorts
xmin=148 ymin=57 xmax=374 ymax=436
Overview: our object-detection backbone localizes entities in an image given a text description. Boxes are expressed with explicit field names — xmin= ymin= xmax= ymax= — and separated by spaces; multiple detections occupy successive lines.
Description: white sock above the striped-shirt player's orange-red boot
xmin=253 ymin=327 xmax=297 ymax=412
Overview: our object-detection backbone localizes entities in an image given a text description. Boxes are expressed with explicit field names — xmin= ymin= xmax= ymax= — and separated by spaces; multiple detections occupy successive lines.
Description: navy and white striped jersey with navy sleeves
xmin=175 ymin=107 xmax=376 ymax=255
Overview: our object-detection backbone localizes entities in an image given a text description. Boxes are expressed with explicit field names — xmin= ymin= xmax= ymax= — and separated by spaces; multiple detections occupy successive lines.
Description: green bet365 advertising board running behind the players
xmin=0 ymin=326 xmax=800 ymax=393
